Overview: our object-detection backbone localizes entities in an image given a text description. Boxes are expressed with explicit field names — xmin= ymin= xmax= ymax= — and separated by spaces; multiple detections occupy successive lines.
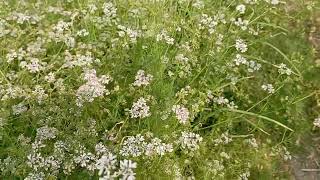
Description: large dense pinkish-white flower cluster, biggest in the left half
xmin=76 ymin=69 xmax=112 ymax=107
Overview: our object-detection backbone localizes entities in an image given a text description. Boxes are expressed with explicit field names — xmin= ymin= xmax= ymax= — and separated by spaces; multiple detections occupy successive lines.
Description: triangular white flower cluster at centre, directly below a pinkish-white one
xmin=129 ymin=97 xmax=151 ymax=118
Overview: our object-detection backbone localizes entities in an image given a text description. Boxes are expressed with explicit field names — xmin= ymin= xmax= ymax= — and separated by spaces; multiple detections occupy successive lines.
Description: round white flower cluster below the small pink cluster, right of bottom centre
xmin=179 ymin=131 xmax=203 ymax=151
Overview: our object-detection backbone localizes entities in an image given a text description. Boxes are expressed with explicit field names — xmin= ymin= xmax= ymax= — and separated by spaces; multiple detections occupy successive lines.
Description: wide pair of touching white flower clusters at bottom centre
xmin=120 ymin=134 xmax=173 ymax=157
